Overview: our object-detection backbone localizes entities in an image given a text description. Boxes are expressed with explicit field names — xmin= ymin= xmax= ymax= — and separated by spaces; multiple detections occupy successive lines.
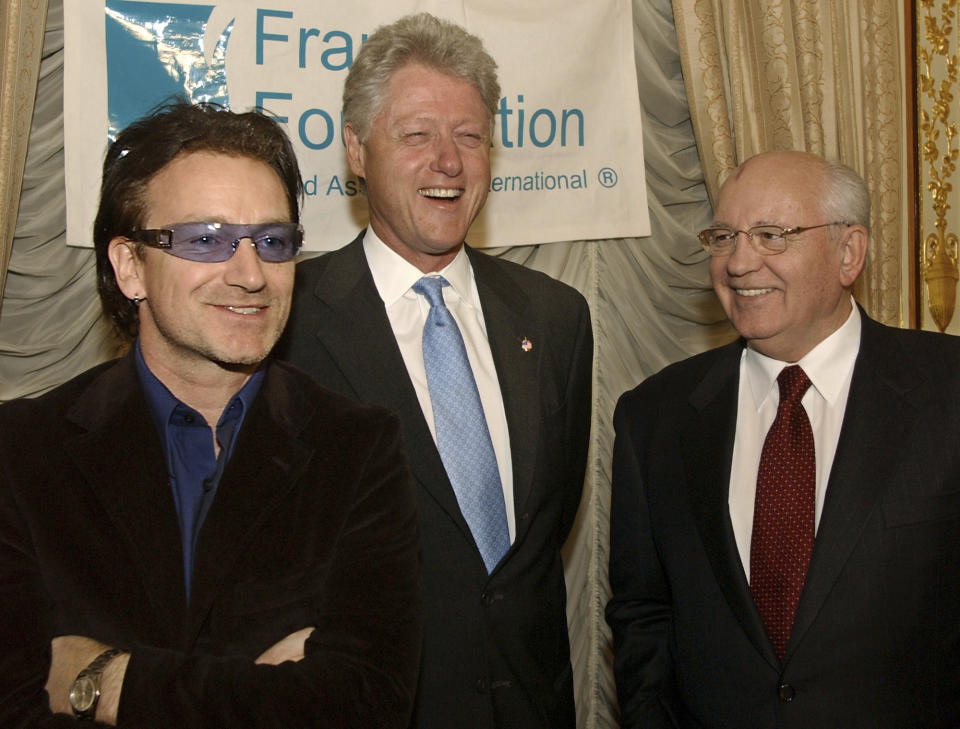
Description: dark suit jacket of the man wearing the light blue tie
xmin=280 ymin=234 xmax=593 ymax=729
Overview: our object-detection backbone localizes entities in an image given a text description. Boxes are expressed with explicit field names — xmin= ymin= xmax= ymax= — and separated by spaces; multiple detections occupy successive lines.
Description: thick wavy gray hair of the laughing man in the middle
xmin=343 ymin=13 xmax=500 ymax=142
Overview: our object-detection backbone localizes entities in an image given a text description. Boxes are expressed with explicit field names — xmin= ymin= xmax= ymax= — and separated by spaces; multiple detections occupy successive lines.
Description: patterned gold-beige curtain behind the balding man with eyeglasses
xmin=673 ymin=0 xmax=909 ymax=326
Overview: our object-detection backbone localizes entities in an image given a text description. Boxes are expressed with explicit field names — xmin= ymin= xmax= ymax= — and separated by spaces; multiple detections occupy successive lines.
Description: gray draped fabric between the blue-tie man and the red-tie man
xmin=493 ymin=0 xmax=736 ymax=729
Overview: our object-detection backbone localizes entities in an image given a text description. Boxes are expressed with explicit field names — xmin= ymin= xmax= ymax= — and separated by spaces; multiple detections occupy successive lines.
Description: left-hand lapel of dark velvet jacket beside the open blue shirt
xmin=64 ymin=356 xmax=186 ymax=641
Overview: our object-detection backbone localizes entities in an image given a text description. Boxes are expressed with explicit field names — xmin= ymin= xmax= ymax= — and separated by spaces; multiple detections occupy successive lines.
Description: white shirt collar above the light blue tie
xmin=363 ymin=227 xmax=480 ymax=309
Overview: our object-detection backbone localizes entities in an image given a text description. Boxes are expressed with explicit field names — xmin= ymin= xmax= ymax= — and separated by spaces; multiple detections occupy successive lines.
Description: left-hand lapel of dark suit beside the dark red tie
xmin=681 ymin=341 xmax=779 ymax=666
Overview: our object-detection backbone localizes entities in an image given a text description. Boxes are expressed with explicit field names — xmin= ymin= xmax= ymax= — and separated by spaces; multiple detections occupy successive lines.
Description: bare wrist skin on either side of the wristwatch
xmin=46 ymin=635 xmax=130 ymax=724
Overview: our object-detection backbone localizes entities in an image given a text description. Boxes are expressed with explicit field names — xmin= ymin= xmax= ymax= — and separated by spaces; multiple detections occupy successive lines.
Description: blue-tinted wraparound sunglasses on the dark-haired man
xmin=128 ymin=223 xmax=303 ymax=263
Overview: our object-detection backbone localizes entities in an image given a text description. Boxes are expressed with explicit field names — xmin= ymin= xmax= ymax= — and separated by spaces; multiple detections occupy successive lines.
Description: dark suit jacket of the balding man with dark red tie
xmin=607 ymin=316 xmax=960 ymax=729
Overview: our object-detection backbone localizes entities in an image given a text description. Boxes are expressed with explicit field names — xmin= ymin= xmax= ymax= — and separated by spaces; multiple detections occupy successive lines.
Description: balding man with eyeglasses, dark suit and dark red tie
xmin=607 ymin=152 xmax=960 ymax=729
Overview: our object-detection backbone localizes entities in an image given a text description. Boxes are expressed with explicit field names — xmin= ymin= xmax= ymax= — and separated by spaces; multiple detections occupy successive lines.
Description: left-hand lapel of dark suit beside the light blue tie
xmin=313 ymin=233 xmax=470 ymax=536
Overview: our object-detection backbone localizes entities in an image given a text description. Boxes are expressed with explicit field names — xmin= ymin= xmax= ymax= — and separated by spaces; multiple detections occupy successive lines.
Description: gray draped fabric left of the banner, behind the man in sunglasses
xmin=0 ymin=0 xmax=118 ymax=401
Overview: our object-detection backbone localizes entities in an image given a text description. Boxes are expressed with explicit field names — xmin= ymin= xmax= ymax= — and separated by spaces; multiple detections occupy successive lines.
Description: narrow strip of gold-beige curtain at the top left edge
xmin=0 ymin=0 xmax=47 ymax=306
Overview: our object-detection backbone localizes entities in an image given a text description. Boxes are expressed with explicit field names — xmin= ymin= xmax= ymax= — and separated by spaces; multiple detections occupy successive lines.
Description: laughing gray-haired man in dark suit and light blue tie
xmin=280 ymin=14 xmax=593 ymax=729
